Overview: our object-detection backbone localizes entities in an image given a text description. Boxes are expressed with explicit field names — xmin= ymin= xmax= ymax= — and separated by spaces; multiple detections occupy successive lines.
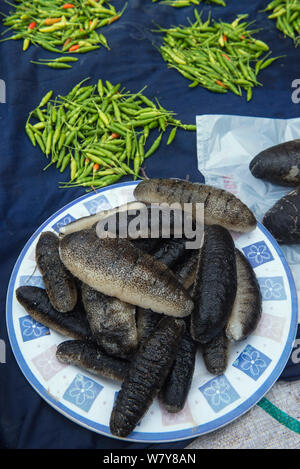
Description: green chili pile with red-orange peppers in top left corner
xmin=2 ymin=0 xmax=126 ymax=58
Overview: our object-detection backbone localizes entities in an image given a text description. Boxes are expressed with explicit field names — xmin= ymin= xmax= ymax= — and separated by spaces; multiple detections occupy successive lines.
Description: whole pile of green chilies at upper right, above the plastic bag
xmin=158 ymin=9 xmax=278 ymax=101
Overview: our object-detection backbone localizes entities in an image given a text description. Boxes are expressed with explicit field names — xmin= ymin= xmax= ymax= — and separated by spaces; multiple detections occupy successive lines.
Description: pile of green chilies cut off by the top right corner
xmin=264 ymin=0 xmax=300 ymax=40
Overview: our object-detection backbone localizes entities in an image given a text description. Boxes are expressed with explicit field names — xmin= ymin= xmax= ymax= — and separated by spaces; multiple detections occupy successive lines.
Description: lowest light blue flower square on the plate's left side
xmin=63 ymin=373 xmax=103 ymax=412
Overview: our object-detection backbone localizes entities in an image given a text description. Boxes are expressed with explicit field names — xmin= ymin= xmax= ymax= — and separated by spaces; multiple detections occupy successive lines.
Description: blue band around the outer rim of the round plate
xmin=6 ymin=181 xmax=298 ymax=443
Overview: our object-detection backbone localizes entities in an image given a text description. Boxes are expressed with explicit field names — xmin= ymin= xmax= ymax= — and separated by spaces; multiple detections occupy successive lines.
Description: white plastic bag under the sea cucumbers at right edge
xmin=196 ymin=115 xmax=300 ymax=320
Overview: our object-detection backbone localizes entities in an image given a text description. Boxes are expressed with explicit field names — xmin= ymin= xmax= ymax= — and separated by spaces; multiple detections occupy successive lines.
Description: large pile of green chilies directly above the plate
xmin=25 ymin=79 xmax=196 ymax=188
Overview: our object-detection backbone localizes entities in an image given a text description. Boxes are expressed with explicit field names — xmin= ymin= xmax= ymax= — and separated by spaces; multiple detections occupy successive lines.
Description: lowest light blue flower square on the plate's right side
xmin=199 ymin=375 xmax=240 ymax=412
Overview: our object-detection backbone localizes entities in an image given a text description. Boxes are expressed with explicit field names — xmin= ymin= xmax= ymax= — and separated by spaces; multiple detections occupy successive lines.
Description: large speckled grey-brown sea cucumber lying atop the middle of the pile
xmin=60 ymin=230 xmax=193 ymax=317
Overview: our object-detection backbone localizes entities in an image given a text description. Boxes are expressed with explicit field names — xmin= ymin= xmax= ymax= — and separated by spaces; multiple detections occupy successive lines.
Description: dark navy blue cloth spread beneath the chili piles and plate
xmin=0 ymin=0 xmax=300 ymax=449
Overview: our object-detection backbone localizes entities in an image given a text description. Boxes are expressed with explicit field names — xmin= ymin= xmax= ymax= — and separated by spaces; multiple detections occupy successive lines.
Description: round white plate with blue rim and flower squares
xmin=6 ymin=182 xmax=298 ymax=442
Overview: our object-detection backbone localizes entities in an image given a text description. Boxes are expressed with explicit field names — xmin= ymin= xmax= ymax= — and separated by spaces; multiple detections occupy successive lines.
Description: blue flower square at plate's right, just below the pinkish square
xmin=233 ymin=344 xmax=272 ymax=381
